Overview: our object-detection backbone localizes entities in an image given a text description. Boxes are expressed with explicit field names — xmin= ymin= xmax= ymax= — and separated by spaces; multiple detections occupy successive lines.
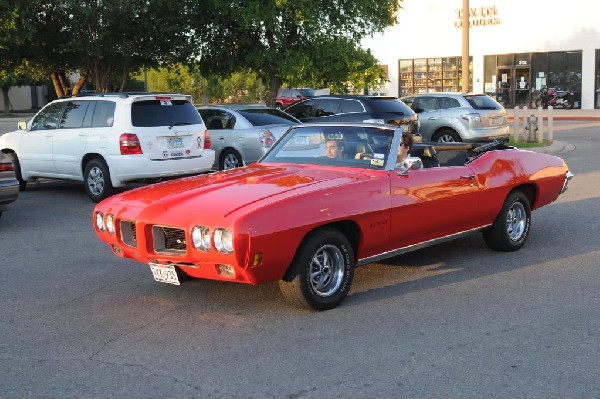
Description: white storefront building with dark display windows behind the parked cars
xmin=363 ymin=0 xmax=600 ymax=109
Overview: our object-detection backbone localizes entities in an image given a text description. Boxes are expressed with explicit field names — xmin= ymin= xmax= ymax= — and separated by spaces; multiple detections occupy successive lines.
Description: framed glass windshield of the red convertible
xmin=259 ymin=125 xmax=394 ymax=169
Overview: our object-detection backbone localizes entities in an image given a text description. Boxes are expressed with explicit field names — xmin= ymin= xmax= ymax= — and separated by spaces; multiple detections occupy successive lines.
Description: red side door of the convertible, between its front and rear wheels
xmin=390 ymin=166 xmax=481 ymax=248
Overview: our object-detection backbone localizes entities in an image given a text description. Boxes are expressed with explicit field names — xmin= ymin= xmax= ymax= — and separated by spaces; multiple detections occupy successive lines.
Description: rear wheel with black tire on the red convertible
xmin=483 ymin=191 xmax=531 ymax=252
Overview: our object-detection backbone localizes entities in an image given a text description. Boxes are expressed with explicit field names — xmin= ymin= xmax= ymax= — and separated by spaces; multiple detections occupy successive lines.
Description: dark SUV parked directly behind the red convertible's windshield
xmin=285 ymin=95 xmax=418 ymax=138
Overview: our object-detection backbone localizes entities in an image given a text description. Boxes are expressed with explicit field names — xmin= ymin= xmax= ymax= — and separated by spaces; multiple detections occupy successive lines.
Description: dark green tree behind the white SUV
xmin=16 ymin=0 xmax=189 ymax=96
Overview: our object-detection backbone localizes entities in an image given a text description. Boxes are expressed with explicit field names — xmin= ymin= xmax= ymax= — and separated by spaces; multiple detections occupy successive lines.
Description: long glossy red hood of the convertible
xmin=113 ymin=164 xmax=361 ymax=216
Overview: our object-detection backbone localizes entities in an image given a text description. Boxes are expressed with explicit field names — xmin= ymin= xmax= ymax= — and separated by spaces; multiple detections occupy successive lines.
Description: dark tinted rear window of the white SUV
xmin=131 ymin=100 xmax=202 ymax=127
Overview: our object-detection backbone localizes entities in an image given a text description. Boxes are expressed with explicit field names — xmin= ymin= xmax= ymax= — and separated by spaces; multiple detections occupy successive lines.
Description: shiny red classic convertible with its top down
xmin=93 ymin=124 xmax=572 ymax=310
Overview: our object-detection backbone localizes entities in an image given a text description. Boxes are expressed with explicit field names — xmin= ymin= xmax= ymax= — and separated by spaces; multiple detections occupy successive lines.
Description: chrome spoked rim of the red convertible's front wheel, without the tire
xmin=310 ymin=245 xmax=345 ymax=297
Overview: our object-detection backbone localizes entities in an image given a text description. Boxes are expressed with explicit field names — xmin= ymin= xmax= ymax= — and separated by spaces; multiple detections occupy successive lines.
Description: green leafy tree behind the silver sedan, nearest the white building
xmin=189 ymin=0 xmax=399 ymax=105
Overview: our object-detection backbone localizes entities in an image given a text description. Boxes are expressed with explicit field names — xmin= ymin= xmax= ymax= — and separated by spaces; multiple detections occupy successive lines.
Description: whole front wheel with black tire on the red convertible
xmin=279 ymin=229 xmax=354 ymax=310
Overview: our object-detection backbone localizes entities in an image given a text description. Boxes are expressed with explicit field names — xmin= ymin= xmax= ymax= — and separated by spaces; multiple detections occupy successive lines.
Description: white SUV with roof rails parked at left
xmin=0 ymin=93 xmax=215 ymax=202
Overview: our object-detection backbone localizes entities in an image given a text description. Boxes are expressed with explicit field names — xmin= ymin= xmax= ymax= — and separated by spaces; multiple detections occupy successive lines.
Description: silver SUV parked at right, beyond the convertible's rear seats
xmin=402 ymin=93 xmax=510 ymax=142
